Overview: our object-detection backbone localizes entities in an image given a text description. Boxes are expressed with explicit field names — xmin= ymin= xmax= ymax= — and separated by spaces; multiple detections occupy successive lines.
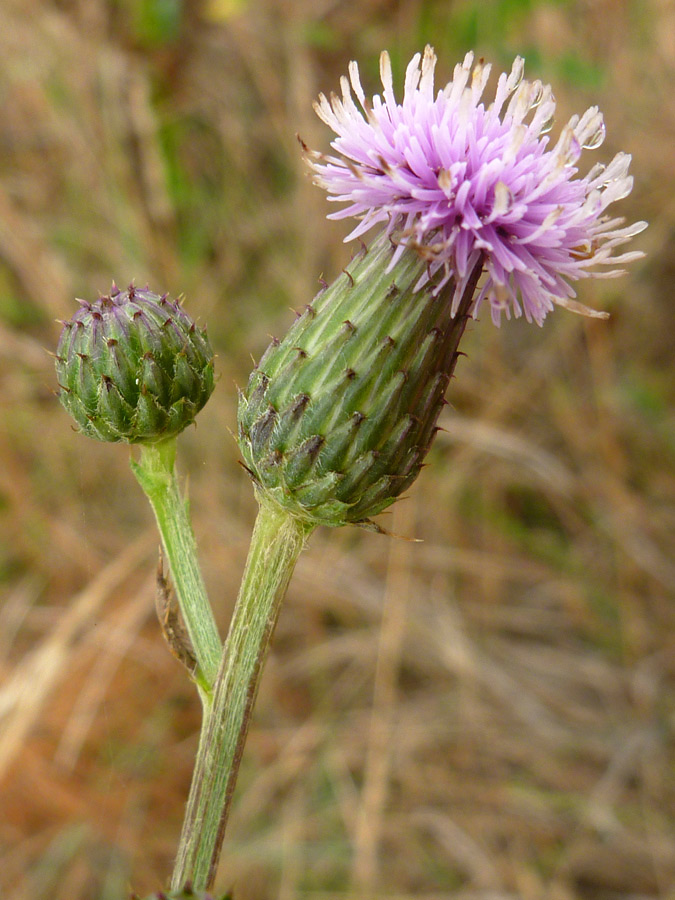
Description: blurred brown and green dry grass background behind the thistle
xmin=0 ymin=0 xmax=675 ymax=900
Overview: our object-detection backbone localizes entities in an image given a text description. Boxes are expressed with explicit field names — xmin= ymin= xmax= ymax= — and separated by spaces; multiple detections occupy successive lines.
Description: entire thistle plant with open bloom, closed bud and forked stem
xmin=57 ymin=47 xmax=645 ymax=892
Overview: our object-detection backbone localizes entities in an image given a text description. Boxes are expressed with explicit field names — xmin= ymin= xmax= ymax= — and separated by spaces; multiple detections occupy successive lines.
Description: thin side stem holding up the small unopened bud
xmin=131 ymin=438 xmax=222 ymax=684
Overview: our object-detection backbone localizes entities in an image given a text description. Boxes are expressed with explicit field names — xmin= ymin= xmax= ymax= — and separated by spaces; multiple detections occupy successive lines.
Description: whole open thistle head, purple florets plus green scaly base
xmin=239 ymin=47 xmax=645 ymax=525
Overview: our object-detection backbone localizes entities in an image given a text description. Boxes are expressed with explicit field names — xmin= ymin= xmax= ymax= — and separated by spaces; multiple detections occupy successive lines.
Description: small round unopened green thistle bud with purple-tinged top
xmin=56 ymin=285 xmax=214 ymax=444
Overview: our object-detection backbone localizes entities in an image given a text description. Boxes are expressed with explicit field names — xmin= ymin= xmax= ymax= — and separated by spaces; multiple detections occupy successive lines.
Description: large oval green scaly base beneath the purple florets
xmin=239 ymin=235 xmax=480 ymax=525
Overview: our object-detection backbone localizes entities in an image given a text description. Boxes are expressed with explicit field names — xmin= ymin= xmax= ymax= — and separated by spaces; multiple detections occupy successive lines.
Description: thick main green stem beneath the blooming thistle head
xmin=171 ymin=499 xmax=314 ymax=890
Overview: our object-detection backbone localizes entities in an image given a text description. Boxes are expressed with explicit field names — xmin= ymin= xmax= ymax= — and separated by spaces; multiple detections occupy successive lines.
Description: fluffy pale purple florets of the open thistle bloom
xmin=308 ymin=46 xmax=646 ymax=325
